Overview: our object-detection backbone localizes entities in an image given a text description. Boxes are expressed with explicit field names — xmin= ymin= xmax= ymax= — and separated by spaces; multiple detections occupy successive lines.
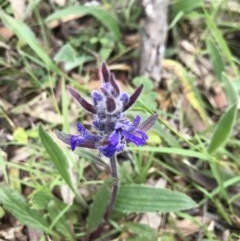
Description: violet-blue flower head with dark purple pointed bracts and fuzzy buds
xmin=56 ymin=63 xmax=157 ymax=157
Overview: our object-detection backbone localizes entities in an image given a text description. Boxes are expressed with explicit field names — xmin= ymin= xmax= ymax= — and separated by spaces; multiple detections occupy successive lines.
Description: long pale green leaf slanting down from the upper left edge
xmin=0 ymin=10 xmax=55 ymax=69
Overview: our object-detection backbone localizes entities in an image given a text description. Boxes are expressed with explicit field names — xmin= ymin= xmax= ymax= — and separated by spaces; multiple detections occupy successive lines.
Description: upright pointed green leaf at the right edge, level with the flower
xmin=208 ymin=104 xmax=237 ymax=153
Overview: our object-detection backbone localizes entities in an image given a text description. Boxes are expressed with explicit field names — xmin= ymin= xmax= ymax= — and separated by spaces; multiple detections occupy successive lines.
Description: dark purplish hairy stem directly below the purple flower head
xmin=105 ymin=155 xmax=119 ymax=222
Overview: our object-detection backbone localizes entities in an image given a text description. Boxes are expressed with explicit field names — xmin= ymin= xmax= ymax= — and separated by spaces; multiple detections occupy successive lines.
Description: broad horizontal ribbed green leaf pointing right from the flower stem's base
xmin=115 ymin=184 xmax=196 ymax=213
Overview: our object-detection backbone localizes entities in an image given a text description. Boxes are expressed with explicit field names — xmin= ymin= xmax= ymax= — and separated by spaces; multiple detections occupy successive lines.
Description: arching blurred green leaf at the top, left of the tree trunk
xmin=46 ymin=5 xmax=121 ymax=40
